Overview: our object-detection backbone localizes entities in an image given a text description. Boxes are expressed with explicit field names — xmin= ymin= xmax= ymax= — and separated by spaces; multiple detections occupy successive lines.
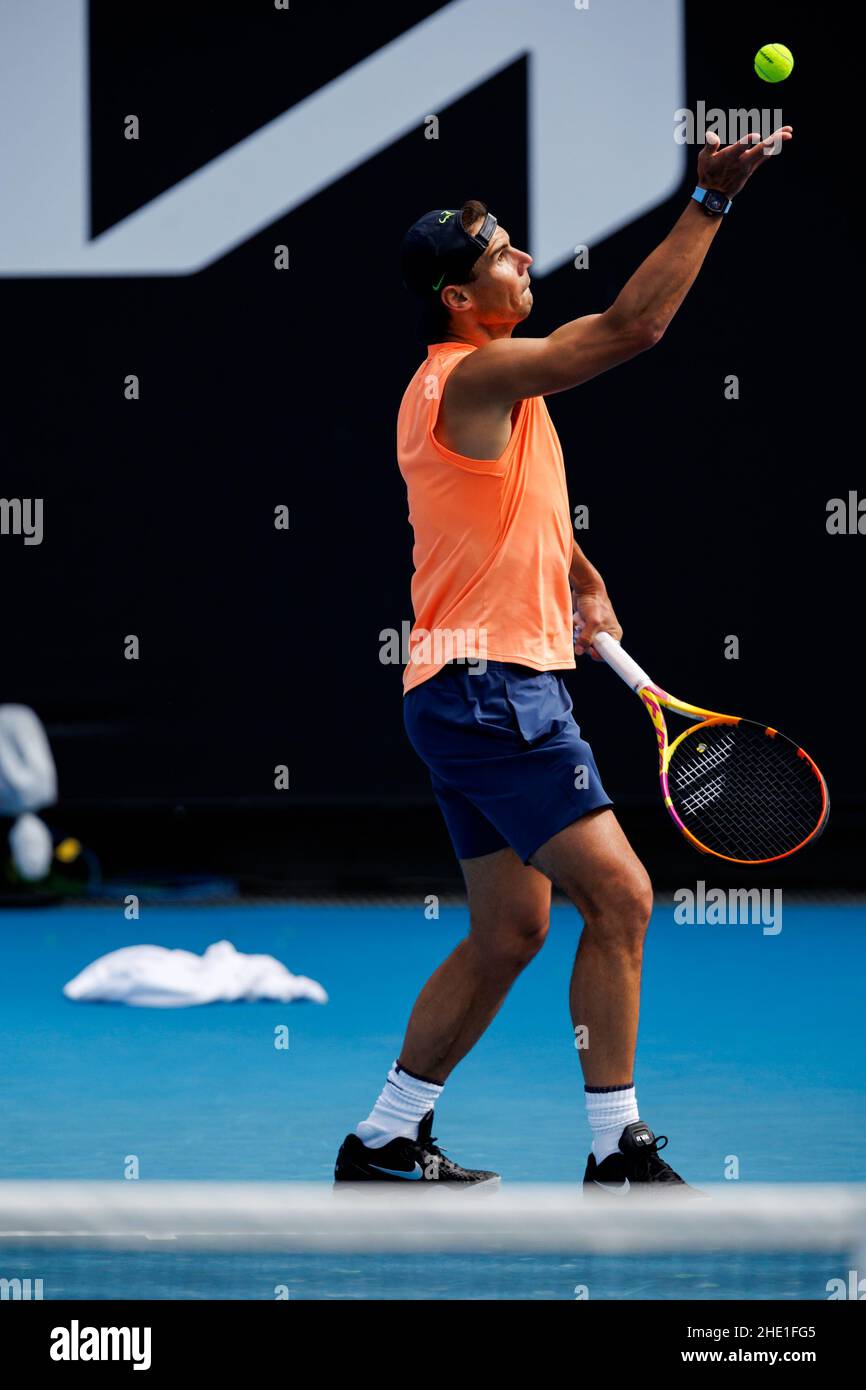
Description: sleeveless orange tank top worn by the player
xmin=398 ymin=343 xmax=574 ymax=692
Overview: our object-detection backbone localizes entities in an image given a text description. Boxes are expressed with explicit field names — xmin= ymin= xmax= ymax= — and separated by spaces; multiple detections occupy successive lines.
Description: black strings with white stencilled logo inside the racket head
xmin=669 ymin=720 xmax=824 ymax=860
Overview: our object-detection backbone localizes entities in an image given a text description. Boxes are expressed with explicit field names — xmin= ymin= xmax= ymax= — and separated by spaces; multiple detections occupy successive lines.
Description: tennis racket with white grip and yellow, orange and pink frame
xmin=592 ymin=632 xmax=830 ymax=865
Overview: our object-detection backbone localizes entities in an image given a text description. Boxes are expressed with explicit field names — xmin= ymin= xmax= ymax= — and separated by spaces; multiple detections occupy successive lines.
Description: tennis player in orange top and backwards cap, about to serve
xmin=335 ymin=126 xmax=792 ymax=1195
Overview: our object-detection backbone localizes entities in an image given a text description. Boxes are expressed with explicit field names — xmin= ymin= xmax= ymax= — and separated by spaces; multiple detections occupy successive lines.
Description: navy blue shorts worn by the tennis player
xmin=403 ymin=662 xmax=613 ymax=863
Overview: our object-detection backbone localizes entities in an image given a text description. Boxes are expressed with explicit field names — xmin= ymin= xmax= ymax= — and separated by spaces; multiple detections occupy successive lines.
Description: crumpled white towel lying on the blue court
xmin=63 ymin=941 xmax=328 ymax=1009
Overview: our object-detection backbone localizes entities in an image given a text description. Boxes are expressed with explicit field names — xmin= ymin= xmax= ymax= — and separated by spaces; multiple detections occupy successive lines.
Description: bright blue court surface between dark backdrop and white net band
xmin=0 ymin=901 xmax=866 ymax=1183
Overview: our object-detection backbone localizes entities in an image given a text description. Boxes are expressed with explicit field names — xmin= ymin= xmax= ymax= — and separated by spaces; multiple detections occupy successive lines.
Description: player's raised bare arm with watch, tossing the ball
xmin=443 ymin=125 xmax=792 ymax=414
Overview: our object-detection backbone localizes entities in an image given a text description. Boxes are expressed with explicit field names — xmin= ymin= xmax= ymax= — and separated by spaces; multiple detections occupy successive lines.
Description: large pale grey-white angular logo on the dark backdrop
xmin=0 ymin=0 xmax=688 ymax=275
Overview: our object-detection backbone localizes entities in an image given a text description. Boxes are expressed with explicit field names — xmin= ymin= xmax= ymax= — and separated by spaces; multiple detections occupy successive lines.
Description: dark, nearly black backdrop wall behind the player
xmin=0 ymin=0 xmax=866 ymax=877
